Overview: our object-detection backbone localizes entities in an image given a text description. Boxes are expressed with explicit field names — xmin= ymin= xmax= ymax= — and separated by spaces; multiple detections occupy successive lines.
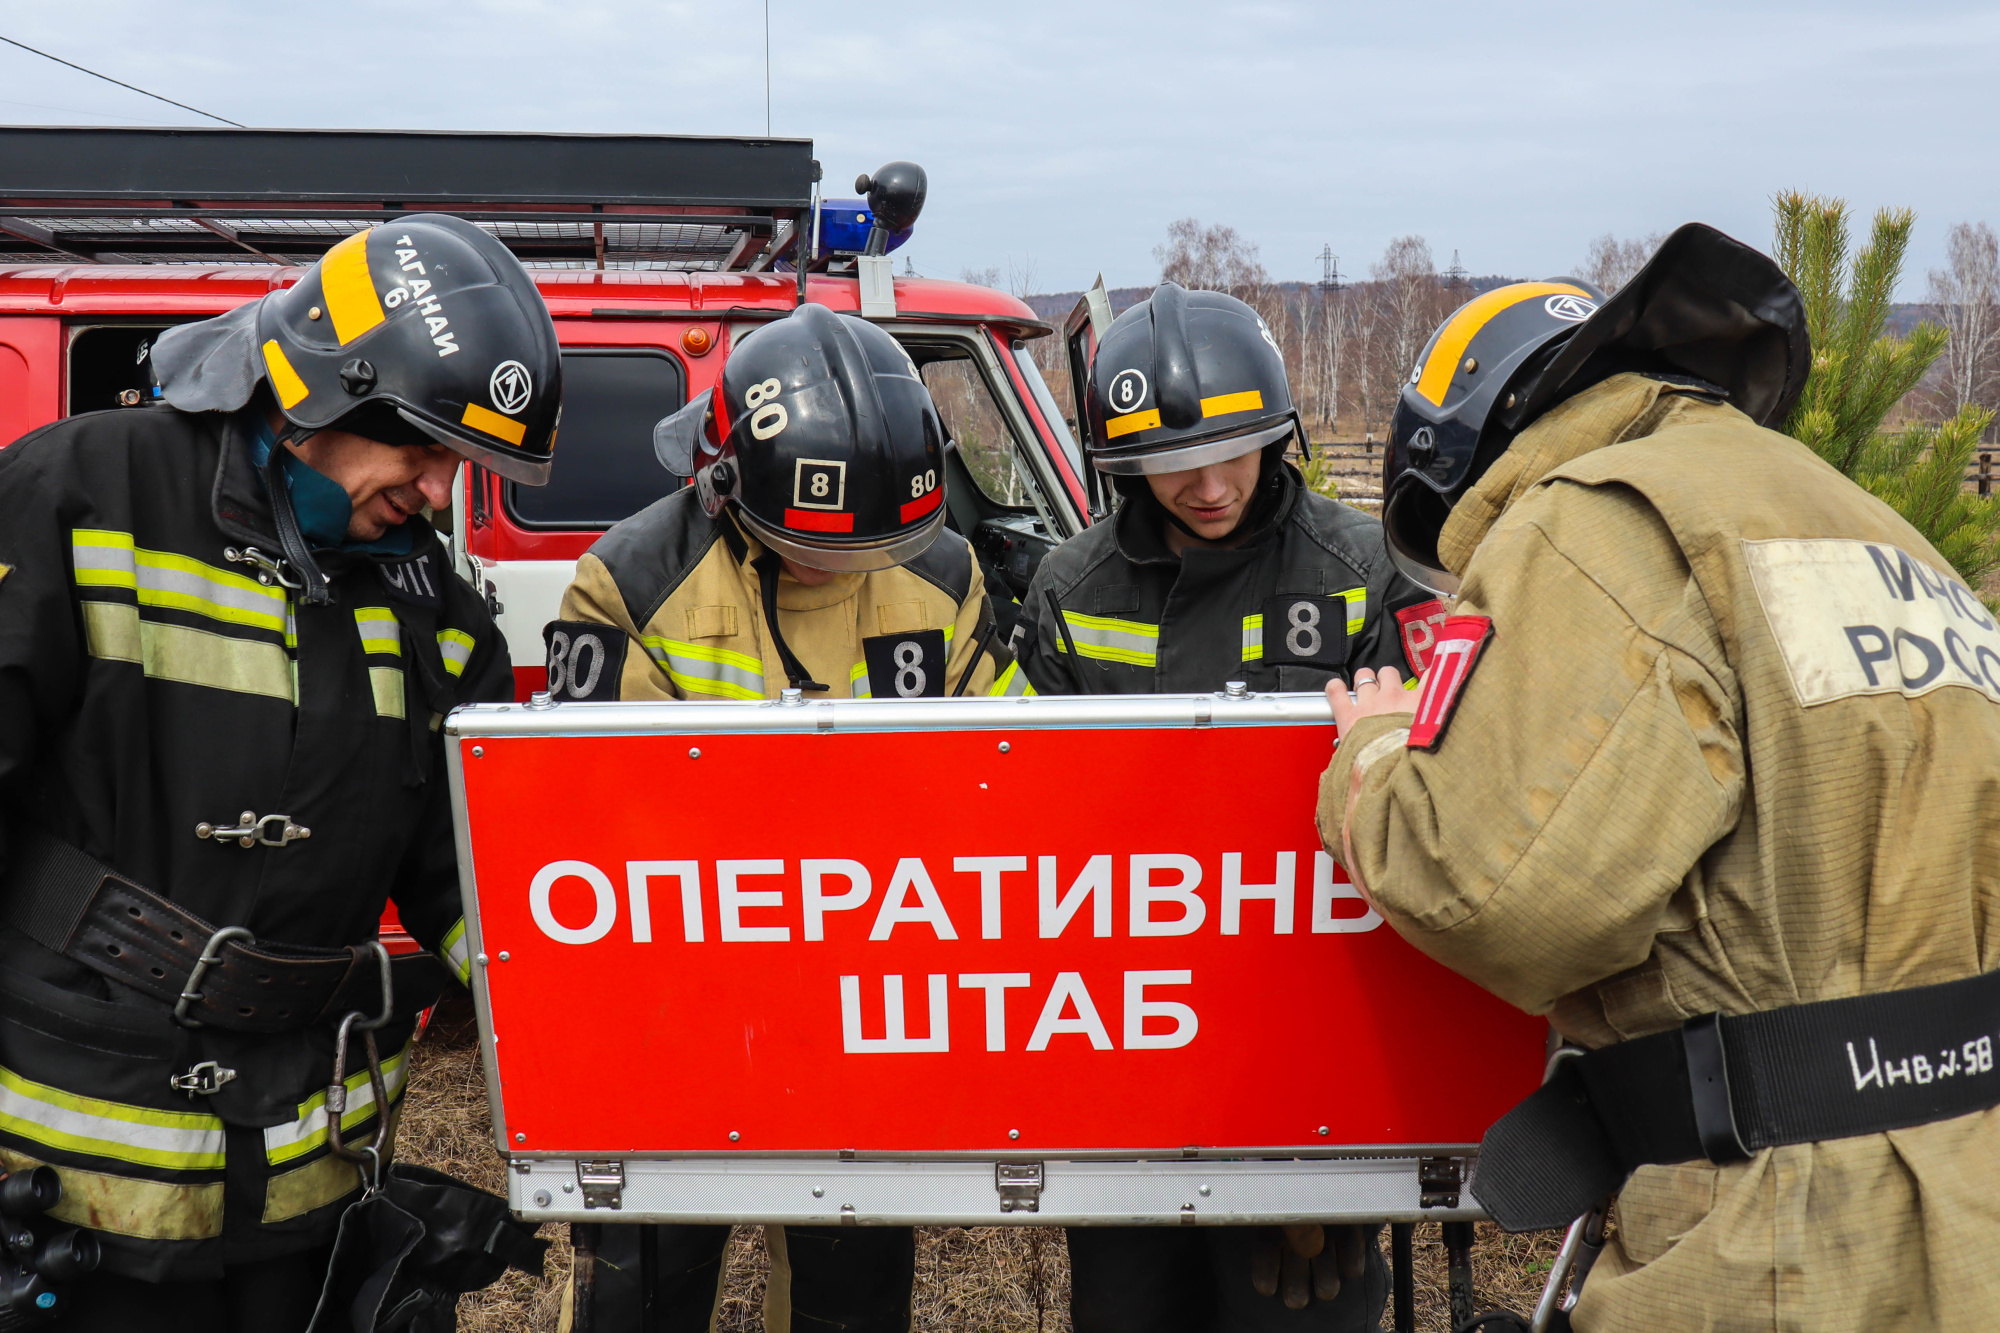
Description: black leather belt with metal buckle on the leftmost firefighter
xmin=0 ymin=825 xmax=444 ymax=1033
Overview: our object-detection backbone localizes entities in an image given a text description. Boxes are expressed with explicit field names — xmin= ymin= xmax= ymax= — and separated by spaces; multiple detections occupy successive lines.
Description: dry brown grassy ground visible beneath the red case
xmin=396 ymin=1005 xmax=1560 ymax=1333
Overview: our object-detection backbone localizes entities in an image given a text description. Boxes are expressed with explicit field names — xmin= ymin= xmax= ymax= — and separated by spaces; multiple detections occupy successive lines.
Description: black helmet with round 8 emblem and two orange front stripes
xmin=1084 ymin=282 xmax=1306 ymax=476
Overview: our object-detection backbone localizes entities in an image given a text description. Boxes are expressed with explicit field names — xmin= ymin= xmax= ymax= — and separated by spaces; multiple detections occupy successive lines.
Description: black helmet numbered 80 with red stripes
xmin=652 ymin=304 xmax=944 ymax=572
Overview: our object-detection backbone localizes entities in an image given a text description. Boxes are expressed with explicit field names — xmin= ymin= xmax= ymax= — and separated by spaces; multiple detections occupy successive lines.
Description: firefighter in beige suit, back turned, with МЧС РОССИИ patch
xmin=1320 ymin=226 xmax=2000 ymax=1331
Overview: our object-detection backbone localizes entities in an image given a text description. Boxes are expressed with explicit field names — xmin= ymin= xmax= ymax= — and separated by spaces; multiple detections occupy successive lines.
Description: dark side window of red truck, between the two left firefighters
xmin=506 ymin=348 xmax=688 ymax=528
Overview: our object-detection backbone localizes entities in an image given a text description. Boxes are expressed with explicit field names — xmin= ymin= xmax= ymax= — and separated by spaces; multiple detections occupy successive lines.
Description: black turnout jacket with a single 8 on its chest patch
xmin=1014 ymin=464 xmax=1430 ymax=695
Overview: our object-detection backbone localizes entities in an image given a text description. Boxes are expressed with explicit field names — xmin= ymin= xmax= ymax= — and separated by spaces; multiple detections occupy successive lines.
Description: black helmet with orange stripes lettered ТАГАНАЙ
xmin=152 ymin=212 xmax=562 ymax=486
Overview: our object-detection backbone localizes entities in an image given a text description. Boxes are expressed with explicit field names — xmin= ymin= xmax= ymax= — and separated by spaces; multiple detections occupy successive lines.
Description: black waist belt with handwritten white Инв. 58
xmin=1472 ymin=960 xmax=2000 ymax=1231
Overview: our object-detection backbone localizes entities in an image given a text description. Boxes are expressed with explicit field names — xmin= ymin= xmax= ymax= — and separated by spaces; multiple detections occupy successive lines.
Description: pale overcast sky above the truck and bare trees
xmin=0 ymin=0 xmax=2000 ymax=298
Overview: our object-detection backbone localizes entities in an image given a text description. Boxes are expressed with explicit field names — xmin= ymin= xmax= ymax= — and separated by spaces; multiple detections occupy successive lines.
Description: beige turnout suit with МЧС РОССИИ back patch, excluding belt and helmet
xmin=1320 ymin=374 xmax=2000 ymax=1331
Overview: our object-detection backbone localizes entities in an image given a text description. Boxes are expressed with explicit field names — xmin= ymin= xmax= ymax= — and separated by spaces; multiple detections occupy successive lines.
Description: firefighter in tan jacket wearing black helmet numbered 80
xmin=544 ymin=306 xmax=1030 ymax=1333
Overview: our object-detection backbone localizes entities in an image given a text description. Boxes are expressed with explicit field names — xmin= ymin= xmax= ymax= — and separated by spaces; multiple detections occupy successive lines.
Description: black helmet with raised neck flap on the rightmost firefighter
xmin=1382 ymin=222 xmax=1812 ymax=592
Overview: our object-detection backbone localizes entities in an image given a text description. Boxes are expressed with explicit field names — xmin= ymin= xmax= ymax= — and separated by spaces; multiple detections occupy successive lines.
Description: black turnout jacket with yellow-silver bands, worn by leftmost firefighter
xmin=0 ymin=408 xmax=512 ymax=1281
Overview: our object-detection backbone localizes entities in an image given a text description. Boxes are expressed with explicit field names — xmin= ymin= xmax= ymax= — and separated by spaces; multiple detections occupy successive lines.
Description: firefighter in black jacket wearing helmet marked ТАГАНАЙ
xmin=0 ymin=216 xmax=562 ymax=1333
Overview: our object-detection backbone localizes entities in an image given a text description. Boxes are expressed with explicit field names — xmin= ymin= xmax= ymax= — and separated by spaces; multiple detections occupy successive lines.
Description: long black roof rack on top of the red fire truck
xmin=0 ymin=126 xmax=818 ymax=272
